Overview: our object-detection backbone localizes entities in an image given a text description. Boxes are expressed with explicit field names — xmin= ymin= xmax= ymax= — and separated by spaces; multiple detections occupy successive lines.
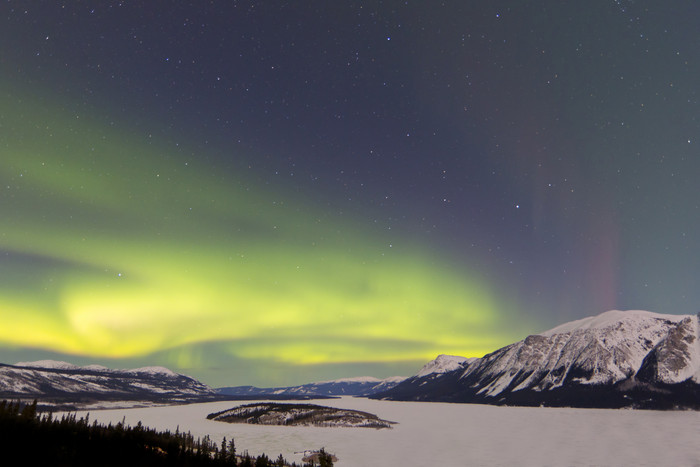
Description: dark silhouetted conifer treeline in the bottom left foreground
xmin=0 ymin=401 xmax=333 ymax=467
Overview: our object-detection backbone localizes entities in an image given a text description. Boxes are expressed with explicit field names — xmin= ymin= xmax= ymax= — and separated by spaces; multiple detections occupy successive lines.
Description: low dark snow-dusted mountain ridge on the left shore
xmin=0 ymin=360 xmax=216 ymax=401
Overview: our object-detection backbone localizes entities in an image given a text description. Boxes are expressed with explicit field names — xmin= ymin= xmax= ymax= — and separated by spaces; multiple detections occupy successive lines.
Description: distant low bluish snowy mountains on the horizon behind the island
xmin=217 ymin=376 xmax=406 ymax=397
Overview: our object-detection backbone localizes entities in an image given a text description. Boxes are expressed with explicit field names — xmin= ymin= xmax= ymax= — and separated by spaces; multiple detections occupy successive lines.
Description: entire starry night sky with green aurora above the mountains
xmin=0 ymin=0 xmax=700 ymax=386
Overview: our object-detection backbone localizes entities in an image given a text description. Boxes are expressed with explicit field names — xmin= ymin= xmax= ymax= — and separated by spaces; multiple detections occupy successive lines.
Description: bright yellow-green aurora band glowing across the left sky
xmin=0 ymin=88 xmax=524 ymax=386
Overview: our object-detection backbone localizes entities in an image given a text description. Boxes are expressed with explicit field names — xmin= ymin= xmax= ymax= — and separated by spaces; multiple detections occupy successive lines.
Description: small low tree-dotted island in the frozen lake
xmin=207 ymin=402 xmax=396 ymax=429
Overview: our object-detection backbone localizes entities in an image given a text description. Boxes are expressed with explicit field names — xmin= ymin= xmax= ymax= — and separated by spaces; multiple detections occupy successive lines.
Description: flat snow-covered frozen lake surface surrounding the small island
xmin=72 ymin=397 xmax=700 ymax=467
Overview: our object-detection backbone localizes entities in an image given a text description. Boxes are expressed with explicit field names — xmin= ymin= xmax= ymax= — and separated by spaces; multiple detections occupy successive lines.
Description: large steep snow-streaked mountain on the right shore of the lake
xmin=371 ymin=310 xmax=700 ymax=408
